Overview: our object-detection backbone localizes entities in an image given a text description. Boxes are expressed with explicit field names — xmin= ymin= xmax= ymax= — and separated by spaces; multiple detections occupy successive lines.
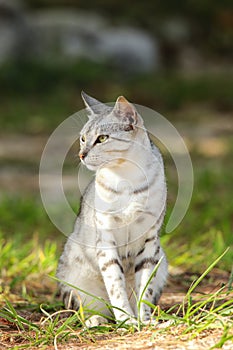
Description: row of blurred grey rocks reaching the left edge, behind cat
xmin=0 ymin=4 xmax=159 ymax=73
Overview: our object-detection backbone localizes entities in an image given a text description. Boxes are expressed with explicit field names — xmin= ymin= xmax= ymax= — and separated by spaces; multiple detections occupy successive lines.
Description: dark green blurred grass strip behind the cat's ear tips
xmin=0 ymin=60 xmax=233 ymax=134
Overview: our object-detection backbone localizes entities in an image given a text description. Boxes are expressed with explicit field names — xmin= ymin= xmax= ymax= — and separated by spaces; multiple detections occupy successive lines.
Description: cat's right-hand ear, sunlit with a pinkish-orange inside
xmin=113 ymin=96 xmax=141 ymax=128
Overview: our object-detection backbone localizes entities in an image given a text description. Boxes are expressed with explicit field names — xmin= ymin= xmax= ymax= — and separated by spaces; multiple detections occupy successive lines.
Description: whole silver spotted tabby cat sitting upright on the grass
xmin=57 ymin=92 xmax=167 ymax=327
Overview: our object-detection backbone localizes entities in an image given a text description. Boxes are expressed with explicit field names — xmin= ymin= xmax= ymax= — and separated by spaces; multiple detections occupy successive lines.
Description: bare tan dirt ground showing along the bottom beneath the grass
xmin=0 ymin=269 xmax=233 ymax=350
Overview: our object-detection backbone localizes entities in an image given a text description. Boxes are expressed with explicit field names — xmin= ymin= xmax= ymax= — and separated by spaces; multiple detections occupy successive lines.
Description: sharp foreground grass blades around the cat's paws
xmin=0 ymin=246 xmax=233 ymax=349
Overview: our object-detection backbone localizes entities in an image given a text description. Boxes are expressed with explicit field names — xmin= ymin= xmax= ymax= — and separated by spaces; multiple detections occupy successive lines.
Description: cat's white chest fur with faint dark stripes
xmin=95 ymin=155 xmax=166 ymax=246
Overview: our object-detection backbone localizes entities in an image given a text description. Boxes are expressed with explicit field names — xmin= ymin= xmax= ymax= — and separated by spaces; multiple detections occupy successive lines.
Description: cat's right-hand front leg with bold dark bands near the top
xmin=135 ymin=232 xmax=167 ymax=322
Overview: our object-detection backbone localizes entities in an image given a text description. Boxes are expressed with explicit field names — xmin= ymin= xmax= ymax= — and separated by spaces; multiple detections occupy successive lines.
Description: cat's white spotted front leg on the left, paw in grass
xmin=97 ymin=230 xmax=134 ymax=322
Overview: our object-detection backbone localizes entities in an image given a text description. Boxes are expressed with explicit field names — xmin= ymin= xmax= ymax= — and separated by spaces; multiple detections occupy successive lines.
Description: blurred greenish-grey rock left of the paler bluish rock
xmin=28 ymin=10 xmax=104 ymax=60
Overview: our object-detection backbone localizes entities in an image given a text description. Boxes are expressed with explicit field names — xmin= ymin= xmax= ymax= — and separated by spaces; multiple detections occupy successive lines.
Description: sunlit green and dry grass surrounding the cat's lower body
xmin=0 ymin=153 xmax=233 ymax=349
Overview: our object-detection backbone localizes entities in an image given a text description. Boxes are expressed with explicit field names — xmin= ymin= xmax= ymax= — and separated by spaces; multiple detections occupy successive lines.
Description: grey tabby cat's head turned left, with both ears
xmin=79 ymin=92 xmax=144 ymax=170
